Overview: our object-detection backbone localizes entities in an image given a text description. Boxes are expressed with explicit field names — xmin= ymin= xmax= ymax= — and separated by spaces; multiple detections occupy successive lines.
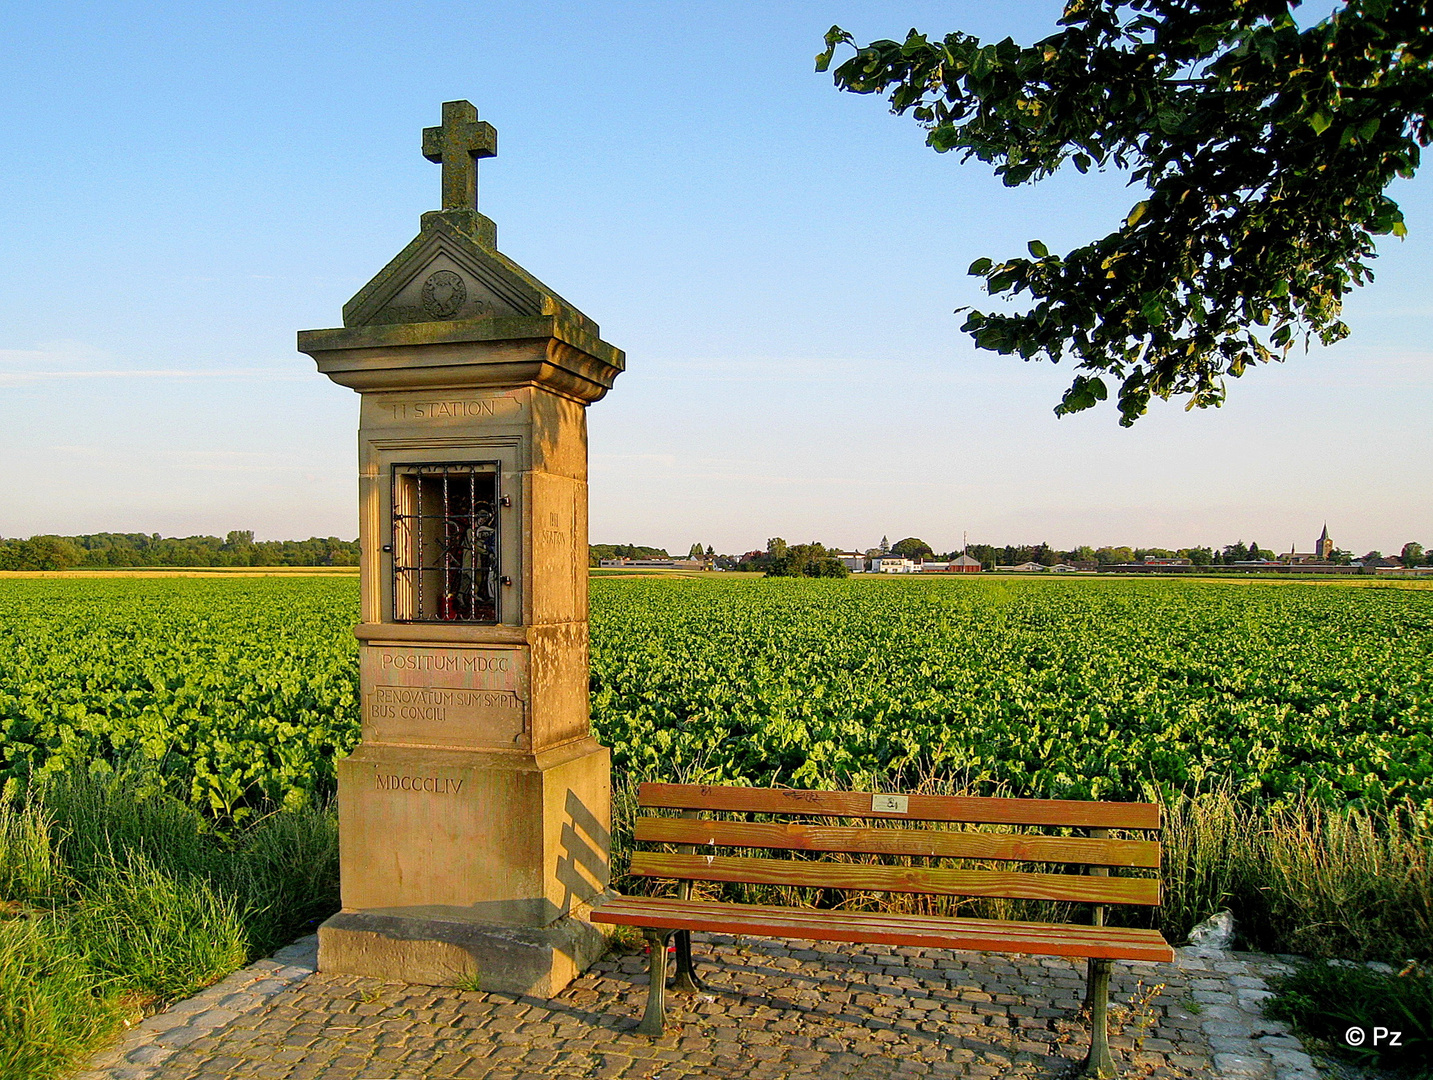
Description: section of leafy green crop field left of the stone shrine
xmin=0 ymin=577 xmax=358 ymax=821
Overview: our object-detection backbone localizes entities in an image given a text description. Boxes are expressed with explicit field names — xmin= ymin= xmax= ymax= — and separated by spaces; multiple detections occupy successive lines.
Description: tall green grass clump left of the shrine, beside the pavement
xmin=0 ymin=771 xmax=338 ymax=1080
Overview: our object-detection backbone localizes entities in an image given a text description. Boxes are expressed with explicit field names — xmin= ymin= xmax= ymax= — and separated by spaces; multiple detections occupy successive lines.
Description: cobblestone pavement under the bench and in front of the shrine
xmin=85 ymin=935 xmax=1317 ymax=1080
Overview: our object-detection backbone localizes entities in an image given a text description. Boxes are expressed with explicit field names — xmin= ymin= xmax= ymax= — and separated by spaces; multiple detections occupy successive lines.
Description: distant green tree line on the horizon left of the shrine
xmin=0 ymin=530 xmax=358 ymax=570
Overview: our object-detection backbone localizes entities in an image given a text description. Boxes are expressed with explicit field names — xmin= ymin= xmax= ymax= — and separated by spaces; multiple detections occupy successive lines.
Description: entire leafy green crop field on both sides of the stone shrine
xmin=0 ymin=577 xmax=1433 ymax=819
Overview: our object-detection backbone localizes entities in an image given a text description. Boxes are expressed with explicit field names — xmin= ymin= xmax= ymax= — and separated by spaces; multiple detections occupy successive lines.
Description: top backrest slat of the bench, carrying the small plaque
xmin=638 ymin=782 xmax=1159 ymax=829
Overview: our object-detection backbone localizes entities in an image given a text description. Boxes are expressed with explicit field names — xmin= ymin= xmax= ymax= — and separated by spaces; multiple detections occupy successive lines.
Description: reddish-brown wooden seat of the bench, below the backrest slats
xmin=592 ymin=897 xmax=1174 ymax=963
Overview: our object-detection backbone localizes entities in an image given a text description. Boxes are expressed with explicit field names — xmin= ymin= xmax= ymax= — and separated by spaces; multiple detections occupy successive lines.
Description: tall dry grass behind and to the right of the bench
xmin=612 ymin=773 xmax=1433 ymax=961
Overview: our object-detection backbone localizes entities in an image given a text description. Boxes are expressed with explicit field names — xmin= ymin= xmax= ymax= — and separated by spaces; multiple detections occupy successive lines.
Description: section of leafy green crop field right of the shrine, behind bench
xmin=592 ymin=579 xmax=1433 ymax=805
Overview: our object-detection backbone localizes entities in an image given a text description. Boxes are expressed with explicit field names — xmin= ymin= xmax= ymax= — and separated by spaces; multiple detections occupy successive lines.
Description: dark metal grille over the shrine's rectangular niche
xmin=391 ymin=461 xmax=504 ymax=623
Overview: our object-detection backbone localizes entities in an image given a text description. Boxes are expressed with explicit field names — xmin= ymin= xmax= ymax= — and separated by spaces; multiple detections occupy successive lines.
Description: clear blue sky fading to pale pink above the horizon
xmin=0 ymin=3 xmax=1433 ymax=553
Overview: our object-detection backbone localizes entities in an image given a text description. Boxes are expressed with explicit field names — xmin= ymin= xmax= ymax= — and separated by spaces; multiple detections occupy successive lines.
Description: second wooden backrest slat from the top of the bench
xmin=633 ymin=818 xmax=1159 ymax=869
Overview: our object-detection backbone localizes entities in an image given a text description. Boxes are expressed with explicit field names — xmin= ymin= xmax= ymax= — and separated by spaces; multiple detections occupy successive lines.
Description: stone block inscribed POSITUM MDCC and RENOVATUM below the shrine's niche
xmin=360 ymin=645 xmax=530 ymax=749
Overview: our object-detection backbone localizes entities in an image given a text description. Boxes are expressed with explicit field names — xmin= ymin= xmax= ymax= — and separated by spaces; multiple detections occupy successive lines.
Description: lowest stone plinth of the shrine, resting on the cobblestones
xmin=318 ymin=911 xmax=608 ymax=997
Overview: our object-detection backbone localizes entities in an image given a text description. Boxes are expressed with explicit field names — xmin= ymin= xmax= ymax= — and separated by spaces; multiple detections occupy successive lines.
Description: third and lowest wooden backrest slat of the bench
xmin=628 ymin=851 xmax=1159 ymax=905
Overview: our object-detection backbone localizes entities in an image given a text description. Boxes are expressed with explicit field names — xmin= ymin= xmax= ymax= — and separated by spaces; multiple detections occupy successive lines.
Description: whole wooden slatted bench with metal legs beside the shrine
xmin=592 ymin=784 xmax=1174 ymax=1076
